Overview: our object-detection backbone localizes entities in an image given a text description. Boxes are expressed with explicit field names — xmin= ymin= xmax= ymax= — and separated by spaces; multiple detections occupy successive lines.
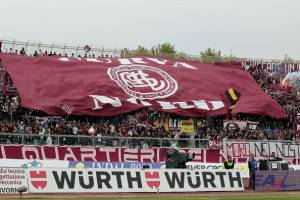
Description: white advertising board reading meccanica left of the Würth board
xmin=0 ymin=167 xmax=27 ymax=194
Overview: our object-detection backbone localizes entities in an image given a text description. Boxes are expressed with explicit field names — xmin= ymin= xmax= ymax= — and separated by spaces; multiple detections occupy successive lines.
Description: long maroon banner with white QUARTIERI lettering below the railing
xmin=0 ymin=145 xmax=223 ymax=163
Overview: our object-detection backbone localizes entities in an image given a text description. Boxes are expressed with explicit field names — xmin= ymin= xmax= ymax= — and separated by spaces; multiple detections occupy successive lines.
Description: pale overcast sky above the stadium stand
xmin=0 ymin=0 xmax=300 ymax=59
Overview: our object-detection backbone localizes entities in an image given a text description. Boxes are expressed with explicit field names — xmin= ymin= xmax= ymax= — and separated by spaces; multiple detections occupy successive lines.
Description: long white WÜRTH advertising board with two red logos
xmin=28 ymin=169 xmax=244 ymax=193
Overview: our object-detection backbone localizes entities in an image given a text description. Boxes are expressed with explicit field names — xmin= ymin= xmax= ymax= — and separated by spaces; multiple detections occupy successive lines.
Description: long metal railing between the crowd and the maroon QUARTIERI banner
xmin=0 ymin=133 xmax=209 ymax=148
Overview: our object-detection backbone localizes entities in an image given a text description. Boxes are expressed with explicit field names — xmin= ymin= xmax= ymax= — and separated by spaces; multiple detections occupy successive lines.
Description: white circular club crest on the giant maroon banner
xmin=107 ymin=65 xmax=178 ymax=99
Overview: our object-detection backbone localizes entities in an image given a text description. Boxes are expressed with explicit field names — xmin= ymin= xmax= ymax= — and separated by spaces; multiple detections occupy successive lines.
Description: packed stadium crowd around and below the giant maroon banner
xmin=0 ymin=48 xmax=300 ymax=145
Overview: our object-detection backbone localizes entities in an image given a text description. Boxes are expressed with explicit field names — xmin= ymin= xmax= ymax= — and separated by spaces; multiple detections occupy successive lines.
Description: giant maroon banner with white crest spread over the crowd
xmin=0 ymin=54 xmax=286 ymax=118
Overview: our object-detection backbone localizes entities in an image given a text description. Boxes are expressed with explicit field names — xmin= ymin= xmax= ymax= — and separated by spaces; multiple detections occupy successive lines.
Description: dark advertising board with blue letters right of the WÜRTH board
xmin=255 ymin=170 xmax=300 ymax=191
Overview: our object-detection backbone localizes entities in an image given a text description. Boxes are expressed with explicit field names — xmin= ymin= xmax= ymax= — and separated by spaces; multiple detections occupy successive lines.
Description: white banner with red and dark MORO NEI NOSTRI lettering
xmin=223 ymin=141 xmax=300 ymax=164
